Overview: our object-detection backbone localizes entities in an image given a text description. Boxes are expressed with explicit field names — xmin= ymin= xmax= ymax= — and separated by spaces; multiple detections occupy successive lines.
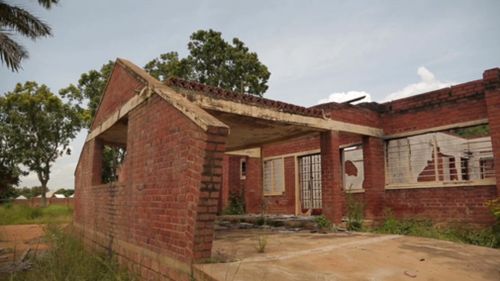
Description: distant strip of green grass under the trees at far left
xmin=0 ymin=203 xmax=73 ymax=225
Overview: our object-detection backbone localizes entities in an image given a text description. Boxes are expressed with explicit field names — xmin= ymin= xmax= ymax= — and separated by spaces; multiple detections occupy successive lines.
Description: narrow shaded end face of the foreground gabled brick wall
xmin=193 ymin=127 xmax=229 ymax=260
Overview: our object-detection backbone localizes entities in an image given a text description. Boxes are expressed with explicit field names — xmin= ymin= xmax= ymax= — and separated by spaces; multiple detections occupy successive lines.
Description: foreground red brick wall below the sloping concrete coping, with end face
xmin=75 ymin=95 xmax=228 ymax=280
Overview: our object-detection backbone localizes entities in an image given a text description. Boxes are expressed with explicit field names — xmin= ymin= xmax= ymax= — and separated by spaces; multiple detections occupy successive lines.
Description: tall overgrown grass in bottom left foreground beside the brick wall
xmin=8 ymin=224 xmax=136 ymax=281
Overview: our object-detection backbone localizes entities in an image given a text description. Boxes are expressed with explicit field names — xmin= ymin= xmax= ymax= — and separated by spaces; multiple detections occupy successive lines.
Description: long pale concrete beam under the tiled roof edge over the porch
xmin=180 ymin=91 xmax=384 ymax=137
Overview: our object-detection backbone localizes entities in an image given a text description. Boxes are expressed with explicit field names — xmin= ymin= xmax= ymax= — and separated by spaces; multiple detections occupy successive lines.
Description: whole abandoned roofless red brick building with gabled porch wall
xmin=74 ymin=59 xmax=500 ymax=280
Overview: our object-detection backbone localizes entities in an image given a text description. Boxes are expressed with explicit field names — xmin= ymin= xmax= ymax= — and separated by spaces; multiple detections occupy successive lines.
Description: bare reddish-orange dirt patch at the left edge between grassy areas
xmin=0 ymin=224 xmax=47 ymax=278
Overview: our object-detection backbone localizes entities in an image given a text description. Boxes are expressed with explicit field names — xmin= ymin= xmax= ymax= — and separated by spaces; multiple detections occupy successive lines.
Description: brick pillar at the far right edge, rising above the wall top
xmin=483 ymin=68 xmax=500 ymax=196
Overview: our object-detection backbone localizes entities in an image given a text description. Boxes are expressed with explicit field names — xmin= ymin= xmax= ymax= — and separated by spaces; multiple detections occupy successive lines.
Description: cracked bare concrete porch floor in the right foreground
xmin=195 ymin=230 xmax=500 ymax=281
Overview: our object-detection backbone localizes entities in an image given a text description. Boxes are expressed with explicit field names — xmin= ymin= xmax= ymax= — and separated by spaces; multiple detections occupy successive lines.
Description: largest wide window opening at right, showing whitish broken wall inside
xmin=386 ymin=125 xmax=495 ymax=185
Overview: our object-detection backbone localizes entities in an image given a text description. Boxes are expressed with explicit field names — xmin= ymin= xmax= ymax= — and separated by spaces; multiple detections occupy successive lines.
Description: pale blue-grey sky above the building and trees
xmin=0 ymin=0 xmax=500 ymax=190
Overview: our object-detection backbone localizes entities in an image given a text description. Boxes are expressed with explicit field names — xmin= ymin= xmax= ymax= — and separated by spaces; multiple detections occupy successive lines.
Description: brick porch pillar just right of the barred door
xmin=320 ymin=131 xmax=345 ymax=224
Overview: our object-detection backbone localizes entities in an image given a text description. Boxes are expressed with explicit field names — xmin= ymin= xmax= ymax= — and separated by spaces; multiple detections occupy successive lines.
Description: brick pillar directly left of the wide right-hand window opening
xmin=363 ymin=136 xmax=385 ymax=220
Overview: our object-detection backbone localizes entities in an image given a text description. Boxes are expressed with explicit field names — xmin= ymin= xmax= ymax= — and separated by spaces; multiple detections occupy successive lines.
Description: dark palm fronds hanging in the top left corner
xmin=0 ymin=0 xmax=59 ymax=71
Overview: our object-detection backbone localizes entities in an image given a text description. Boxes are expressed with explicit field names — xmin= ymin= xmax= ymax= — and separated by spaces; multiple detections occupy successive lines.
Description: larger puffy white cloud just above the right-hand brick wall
xmin=383 ymin=66 xmax=454 ymax=102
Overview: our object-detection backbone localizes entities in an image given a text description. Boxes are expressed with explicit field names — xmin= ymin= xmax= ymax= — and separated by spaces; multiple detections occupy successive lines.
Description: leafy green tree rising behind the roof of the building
xmin=144 ymin=29 xmax=271 ymax=96
